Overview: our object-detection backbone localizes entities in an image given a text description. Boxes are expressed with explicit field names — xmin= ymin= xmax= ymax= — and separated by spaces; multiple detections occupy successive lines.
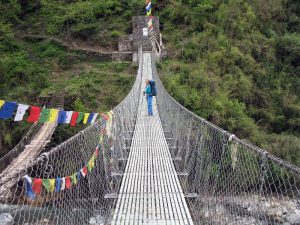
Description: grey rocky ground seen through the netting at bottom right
xmin=202 ymin=194 xmax=300 ymax=225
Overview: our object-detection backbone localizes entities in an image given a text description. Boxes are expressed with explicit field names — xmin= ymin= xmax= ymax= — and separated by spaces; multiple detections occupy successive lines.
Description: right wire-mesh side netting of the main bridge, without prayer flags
xmin=152 ymin=53 xmax=300 ymax=225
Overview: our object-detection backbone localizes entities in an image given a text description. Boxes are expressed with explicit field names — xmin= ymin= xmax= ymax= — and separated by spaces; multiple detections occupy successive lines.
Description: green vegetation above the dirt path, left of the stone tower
xmin=21 ymin=0 xmax=144 ymax=47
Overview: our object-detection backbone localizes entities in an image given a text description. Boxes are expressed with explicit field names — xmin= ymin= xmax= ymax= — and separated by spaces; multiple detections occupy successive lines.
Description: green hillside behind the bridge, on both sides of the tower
xmin=0 ymin=0 xmax=300 ymax=165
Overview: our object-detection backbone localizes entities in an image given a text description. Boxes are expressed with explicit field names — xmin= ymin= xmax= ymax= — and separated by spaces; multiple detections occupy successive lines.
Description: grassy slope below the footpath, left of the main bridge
xmin=0 ymin=37 xmax=137 ymax=157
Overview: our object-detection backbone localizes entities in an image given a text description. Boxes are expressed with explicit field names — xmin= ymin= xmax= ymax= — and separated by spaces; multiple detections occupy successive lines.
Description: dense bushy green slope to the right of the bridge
xmin=158 ymin=0 xmax=300 ymax=165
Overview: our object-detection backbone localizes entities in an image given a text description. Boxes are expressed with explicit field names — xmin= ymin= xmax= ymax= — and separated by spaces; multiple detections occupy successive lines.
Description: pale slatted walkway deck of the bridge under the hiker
xmin=112 ymin=53 xmax=193 ymax=225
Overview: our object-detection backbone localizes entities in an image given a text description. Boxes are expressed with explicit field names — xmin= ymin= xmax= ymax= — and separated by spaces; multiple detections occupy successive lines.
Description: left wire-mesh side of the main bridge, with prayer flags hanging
xmin=0 ymin=50 xmax=142 ymax=225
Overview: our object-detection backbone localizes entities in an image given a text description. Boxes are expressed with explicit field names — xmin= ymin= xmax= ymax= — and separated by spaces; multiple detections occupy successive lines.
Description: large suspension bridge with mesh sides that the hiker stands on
xmin=0 ymin=20 xmax=300 ymax=225
